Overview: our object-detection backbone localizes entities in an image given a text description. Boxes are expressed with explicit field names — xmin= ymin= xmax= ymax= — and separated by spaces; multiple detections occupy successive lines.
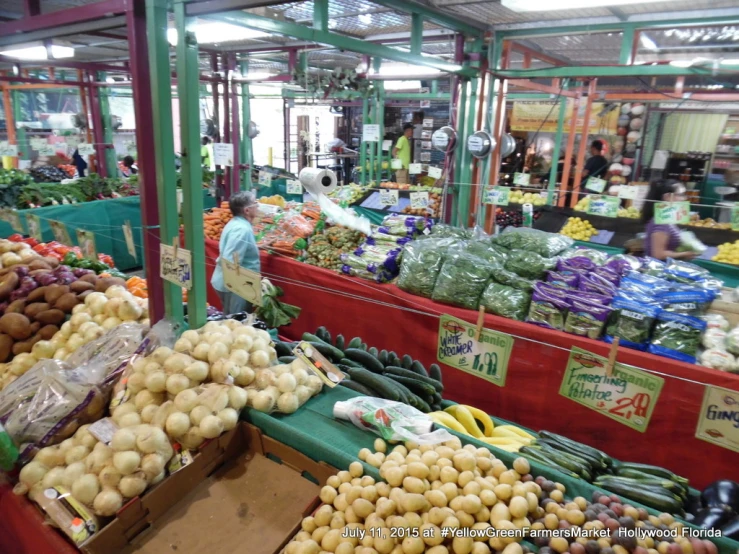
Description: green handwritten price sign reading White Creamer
xmin=437 ymin=315 xmax=514 ymax=387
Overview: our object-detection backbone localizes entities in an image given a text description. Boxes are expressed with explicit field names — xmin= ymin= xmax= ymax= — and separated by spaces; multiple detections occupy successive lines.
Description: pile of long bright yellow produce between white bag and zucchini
xmin=428 ymin=404 xmax=535 ymax=452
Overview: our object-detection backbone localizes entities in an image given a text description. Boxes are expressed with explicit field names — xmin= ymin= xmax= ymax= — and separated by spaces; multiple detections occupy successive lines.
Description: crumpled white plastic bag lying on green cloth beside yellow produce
xmin=334 ymin=396 xmax=453 ymax=444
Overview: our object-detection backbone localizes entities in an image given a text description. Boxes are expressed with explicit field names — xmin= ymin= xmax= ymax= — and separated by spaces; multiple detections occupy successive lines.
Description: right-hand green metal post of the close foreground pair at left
xmin=174 ymin=2 xmax=207 ymax=329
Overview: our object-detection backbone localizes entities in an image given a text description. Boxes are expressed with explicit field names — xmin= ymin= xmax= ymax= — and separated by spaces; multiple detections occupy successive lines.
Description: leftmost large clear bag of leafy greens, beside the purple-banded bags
xmin=398 ymin=238 xmax=462 ymax=298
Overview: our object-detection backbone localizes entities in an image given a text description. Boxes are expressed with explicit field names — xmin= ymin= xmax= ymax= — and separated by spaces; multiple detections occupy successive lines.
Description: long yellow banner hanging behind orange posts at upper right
xmin=511 ymin=99 xmax=621 ymax=135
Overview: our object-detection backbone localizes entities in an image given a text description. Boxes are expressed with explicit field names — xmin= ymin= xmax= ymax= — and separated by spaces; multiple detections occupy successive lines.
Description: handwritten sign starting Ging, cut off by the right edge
xmin=695 ymin=386 xmax=739 ymax=452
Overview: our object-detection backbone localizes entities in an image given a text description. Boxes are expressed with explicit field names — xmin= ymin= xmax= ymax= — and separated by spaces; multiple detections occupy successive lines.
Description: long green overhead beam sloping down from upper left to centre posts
xmin=207 ymin=10 xmax=477 ymax=77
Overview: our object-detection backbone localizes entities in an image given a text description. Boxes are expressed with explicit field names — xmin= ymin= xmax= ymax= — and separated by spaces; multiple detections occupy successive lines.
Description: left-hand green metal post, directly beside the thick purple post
xmin=146 ymin=0 xmax=184 ymax=323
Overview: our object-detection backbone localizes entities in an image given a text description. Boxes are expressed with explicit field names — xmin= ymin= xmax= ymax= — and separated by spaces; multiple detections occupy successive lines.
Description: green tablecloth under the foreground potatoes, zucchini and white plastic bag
xmin=247 ymin=387 xmax=739 ymax=554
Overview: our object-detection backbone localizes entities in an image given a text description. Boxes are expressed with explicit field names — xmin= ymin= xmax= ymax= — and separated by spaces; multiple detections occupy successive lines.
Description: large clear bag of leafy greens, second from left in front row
xmin=431 ymin=252 xmax=495 ymax=310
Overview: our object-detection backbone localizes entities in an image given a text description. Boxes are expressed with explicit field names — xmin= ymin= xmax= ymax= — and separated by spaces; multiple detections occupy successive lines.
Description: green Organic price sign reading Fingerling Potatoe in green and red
xmin=559 ymin=348 xmax=665 ymax=433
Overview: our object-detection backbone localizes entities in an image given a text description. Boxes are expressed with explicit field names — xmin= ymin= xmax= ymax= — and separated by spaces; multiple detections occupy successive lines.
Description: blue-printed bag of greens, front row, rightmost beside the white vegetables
xmin=648 ymin=310 xmax=706 ymax=363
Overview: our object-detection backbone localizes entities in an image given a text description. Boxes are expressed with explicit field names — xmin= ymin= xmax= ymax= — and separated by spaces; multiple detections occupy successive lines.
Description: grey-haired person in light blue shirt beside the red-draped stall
xmin=210 ymin=191 xmax=260 ymax=315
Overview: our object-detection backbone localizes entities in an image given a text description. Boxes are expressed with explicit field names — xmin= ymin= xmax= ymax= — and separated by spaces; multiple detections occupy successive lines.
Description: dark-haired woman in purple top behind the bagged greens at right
xmin=642 ymin=179 xmax=696 ymax=260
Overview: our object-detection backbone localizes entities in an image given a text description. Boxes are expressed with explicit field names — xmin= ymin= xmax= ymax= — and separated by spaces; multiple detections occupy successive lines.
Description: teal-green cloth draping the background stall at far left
xmin=0 ymin=190 xmax=215 ymax=271
